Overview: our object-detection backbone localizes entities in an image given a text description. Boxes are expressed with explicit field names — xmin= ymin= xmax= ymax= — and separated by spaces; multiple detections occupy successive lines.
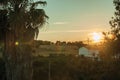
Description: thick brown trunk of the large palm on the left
xmin=4 ymin=31 xmax=32 ymax=80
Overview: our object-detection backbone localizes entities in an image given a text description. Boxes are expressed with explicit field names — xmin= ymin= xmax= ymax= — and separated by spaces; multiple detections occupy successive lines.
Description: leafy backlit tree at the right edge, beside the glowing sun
xmin=102 ymin=0 xmax=120 ymax=59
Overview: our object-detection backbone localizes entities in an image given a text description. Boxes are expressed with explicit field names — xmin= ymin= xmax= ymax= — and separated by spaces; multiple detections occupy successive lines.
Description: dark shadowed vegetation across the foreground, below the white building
xmin=0 ymin=55 xmax=120 ymax=80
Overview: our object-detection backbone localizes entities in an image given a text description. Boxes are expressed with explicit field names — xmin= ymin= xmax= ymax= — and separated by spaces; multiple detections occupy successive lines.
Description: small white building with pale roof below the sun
xmin=79 ymin=47 xmax=99 ymax=57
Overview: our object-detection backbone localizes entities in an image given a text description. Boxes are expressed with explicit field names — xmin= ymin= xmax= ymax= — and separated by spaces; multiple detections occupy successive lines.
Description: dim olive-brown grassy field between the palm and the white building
xmin=34 ymin=45 xmax=78 ymax=56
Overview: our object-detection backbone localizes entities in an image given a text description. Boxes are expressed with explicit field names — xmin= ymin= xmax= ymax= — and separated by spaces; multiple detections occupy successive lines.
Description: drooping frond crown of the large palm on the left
xmin=0 ymin=0 xmax=48 ymax=41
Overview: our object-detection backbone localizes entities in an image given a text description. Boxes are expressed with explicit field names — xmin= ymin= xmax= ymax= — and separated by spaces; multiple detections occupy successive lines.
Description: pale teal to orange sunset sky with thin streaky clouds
xmin=38 ymin=0 xmax=114 ymax=42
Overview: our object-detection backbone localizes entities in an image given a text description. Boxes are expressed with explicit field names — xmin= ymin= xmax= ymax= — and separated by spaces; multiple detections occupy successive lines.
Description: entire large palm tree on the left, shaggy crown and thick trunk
xmin=0 ymin=0 xmax=48 ymax=80
